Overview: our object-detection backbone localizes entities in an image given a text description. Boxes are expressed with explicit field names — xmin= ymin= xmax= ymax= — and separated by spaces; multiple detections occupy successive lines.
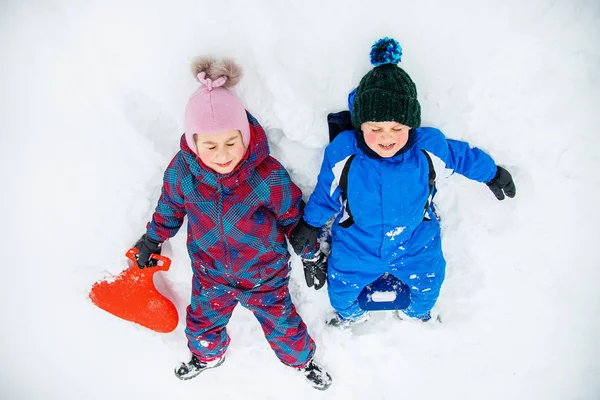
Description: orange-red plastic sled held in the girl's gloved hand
xmin=90 ymin=248 xmax=179 ymax=333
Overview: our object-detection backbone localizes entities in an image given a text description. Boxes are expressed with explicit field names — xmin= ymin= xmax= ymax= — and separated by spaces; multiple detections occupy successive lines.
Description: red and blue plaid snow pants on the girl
xmin=185 ymin=265 xmax=316 ymax=367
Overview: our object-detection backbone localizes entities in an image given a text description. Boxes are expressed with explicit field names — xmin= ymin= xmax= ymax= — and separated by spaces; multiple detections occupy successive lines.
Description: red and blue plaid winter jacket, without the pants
xmin=148 ymin=114 xmax=302 ymax=284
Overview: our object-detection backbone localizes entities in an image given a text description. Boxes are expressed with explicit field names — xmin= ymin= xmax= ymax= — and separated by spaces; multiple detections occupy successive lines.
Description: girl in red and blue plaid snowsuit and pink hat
xmin=135 ymin=58 xmax=331 ymax=390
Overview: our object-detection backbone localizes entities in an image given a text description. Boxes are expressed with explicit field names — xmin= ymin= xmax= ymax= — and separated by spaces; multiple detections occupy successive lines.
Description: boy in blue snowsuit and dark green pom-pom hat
xmin=290 ymin=38 xmax=516 ymax=325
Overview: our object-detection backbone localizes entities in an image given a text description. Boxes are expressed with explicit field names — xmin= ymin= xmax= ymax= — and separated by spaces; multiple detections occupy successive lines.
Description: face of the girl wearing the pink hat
xmin=194 ymin=130 xmax=246 ymax=174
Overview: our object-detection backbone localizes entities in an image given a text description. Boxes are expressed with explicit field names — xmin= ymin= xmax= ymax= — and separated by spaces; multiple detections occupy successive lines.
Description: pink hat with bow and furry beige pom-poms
xmin=185 ymin=58 xmax=250 ymax=153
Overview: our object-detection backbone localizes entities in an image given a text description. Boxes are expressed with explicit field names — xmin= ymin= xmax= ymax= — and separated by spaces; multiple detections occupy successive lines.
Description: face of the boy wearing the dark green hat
xmin=360 ymin=121 xmax=410 ymax=158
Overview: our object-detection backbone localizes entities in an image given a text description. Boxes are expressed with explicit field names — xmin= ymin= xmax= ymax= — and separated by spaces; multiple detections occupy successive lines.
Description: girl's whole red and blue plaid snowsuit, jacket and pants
xmin=147 ymin=114 xmax=315 ymax=366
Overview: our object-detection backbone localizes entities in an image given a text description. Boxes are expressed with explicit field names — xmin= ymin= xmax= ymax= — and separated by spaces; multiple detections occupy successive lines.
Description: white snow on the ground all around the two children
xmin=0 ymin=0 xmax=600 ymax=400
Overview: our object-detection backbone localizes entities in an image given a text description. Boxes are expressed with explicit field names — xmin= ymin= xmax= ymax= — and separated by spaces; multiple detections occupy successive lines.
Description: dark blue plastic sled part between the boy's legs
xmin=358 ymin=272 xmax=410 ymax=311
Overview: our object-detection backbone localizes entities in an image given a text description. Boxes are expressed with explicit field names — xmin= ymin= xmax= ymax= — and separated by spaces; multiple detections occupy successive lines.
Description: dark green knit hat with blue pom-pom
xmin=352 ymin=37 xmax=421 ymax=129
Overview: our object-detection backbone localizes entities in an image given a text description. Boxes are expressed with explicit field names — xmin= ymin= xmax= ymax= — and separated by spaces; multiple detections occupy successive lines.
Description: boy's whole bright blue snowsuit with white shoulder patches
xmin=304 ymin=124 xmax=496 ymax=319
